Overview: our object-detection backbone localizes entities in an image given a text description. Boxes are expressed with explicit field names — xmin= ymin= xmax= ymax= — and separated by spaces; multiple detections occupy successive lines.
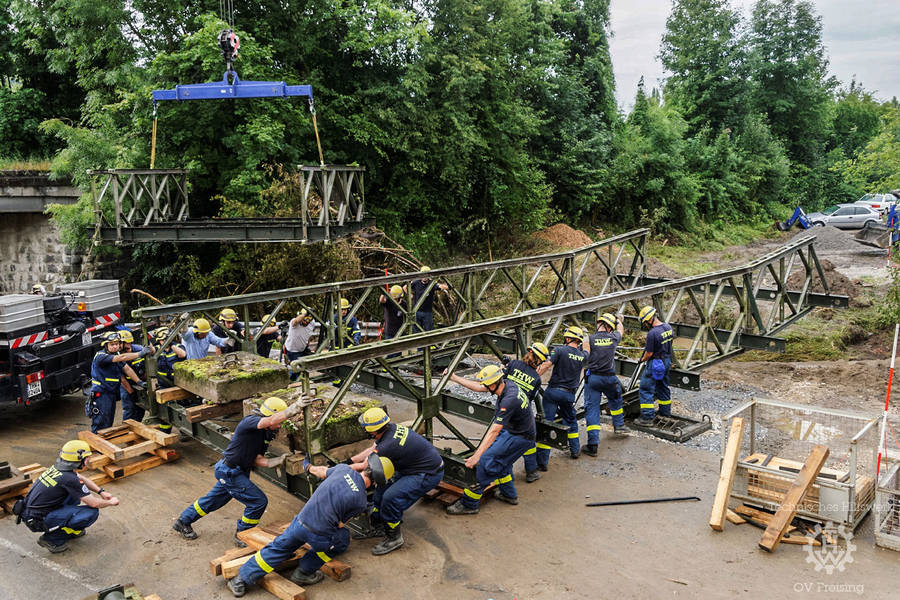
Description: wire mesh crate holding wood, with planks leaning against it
xmin=722 ymin=399 xmax=878 ymax=527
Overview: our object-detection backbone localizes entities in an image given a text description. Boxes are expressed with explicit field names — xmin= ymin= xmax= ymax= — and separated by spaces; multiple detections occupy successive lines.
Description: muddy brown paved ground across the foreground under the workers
xmin=0 ymin=397 xmax=900 ymax=600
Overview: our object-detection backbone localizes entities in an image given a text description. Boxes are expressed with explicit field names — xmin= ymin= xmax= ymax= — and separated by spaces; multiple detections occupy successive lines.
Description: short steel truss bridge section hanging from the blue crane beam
xmin=88 ymin=165 xmax=374 ymax=245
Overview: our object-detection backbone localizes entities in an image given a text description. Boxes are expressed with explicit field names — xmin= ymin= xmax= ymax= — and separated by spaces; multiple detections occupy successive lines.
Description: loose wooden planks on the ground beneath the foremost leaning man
xmin=209 ymin=523 xmax=351 ymax=600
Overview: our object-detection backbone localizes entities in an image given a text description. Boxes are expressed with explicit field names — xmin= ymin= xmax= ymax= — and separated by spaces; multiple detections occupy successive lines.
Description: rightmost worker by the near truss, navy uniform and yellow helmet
xmin=635 ymin=306 xmax=675 ymax=425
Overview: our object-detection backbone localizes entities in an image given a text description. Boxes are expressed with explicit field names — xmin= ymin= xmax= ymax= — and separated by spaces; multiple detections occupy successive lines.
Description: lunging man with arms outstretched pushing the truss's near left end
xmin=172 ymin=397 xmax=303 ymax=548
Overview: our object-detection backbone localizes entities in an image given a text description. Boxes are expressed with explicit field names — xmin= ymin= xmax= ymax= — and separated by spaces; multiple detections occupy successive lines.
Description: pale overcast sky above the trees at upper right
xmin=610 ymin=0 xmax=900 ymax=108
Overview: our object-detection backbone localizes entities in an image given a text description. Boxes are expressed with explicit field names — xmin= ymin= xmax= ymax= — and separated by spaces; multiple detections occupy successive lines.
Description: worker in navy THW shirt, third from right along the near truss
xmin=537 ymin=325 xmax=587 ymax=467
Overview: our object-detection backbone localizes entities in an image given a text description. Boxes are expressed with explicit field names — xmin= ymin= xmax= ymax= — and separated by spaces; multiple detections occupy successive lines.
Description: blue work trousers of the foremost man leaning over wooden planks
xmin=239 ymin=515 xmax=350 ymax=583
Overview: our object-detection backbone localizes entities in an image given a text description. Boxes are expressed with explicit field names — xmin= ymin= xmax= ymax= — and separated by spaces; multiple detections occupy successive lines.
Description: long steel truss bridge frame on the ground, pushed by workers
xmin=133 ymin=230 xmax=848 ymax=497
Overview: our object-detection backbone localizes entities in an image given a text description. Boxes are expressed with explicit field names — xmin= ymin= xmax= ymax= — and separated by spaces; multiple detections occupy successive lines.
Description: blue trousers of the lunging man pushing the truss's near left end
xmin=178 ymin=460 xmax=269 ymax=531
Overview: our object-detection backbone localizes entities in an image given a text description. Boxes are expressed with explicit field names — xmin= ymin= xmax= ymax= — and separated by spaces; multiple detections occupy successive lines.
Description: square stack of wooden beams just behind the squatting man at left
xmin=78 ymin=419 xmax=179 ymax=485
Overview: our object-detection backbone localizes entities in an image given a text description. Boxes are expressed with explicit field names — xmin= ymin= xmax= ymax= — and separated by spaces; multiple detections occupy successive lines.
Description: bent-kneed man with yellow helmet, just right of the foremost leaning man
xmin=350 ymin=408 xmax=444 ymax=556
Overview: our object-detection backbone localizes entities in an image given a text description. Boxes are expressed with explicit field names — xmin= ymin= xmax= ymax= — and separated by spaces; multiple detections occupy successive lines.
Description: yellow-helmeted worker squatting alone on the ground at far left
xmin=13 ymin=440 xmax=119 ymax=553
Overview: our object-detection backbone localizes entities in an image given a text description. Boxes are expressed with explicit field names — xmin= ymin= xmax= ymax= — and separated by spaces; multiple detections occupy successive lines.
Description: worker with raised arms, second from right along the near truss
xmin=583 ymin=313 xmax=627 ymax=456
